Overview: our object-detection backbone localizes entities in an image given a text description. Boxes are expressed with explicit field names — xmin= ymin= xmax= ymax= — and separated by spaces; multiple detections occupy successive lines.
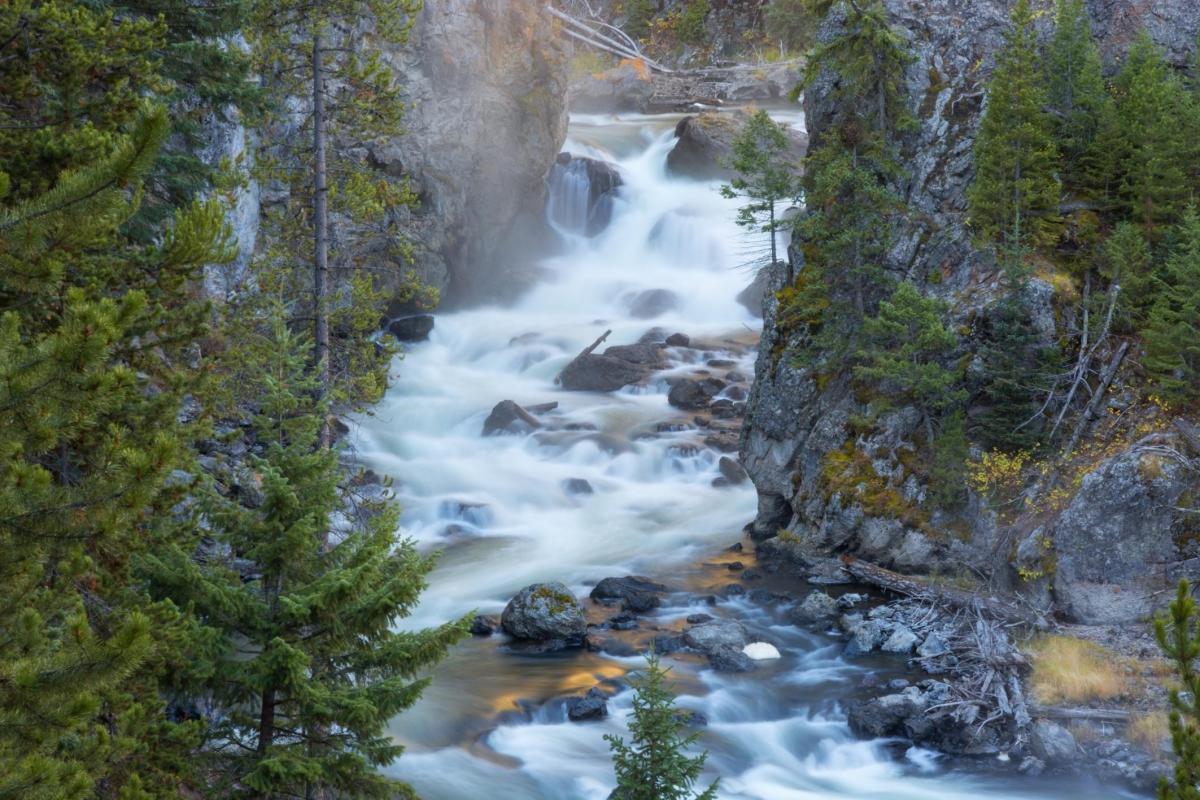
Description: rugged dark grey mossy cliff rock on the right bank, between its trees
xmin=742 ymin=0 xmax=1200 ymax=622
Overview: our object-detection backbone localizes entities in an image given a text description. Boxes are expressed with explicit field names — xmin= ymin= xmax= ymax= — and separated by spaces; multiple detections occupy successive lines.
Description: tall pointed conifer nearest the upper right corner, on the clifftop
xmin=1112 ymin=31 xmax=1200 ymax=237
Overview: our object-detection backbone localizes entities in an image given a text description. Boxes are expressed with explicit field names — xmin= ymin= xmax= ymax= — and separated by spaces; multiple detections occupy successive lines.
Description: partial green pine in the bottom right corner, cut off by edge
xmin=1154 ymin=581 xmax=1200 ymax=800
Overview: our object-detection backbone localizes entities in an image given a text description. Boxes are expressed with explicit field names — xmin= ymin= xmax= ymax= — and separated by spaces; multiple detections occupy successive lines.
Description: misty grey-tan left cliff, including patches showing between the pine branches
xmin=208 ymin=0 xmax=566 ymax=300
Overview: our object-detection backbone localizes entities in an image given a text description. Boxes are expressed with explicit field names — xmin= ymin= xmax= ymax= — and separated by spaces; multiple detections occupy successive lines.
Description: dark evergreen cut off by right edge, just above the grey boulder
xmin=1142 ymin=206 xmax=1200 ymax=403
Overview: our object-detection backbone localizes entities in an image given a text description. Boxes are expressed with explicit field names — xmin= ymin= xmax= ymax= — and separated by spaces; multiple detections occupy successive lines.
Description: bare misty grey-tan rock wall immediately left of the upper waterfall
xmin=384 ymin=0 xmax=568 ymax=299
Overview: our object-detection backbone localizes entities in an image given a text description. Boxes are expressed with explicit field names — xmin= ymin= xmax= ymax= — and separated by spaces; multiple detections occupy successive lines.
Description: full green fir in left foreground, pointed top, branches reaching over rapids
xmin=143 ymin=295 xmax=466 ymax=799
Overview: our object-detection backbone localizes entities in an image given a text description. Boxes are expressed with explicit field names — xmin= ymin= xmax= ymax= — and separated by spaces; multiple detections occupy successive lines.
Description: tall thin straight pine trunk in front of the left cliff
xmin=312 ymin=34 xmax=332 ymax=447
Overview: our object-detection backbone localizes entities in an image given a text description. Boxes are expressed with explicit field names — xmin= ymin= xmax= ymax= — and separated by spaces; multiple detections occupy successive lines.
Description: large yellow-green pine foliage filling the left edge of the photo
xmin=0 ymin=110 xmax=229 ymax=800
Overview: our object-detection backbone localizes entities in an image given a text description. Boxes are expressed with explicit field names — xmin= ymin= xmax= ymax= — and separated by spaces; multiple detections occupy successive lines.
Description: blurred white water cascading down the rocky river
xmin=356 ymin=114 xmax=1137 ymax=800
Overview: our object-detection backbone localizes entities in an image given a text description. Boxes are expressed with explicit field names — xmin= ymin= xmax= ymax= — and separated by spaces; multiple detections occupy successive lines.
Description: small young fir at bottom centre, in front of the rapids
xmin=605 ymin=654 xmax=719 ymax=800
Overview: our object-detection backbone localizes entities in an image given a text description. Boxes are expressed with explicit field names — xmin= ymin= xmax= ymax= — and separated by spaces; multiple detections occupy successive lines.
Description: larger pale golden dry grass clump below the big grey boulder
xmin=1030 ymin=636 xmax=1126 ymax=705
